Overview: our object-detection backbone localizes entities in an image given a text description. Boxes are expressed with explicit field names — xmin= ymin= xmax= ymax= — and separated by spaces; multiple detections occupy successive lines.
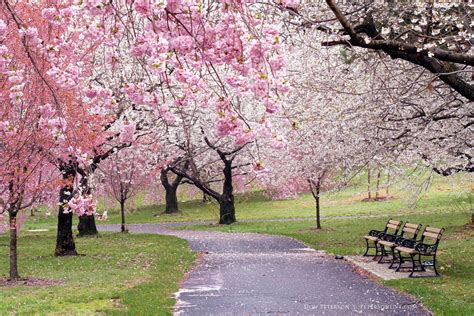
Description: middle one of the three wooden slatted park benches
xmin=377 ymin=223 xmax=421 ymax=269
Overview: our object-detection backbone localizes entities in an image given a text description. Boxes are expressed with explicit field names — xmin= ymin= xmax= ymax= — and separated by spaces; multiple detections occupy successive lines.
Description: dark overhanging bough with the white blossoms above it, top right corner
xmin=326 ymin=0 xmax=474 ymax=101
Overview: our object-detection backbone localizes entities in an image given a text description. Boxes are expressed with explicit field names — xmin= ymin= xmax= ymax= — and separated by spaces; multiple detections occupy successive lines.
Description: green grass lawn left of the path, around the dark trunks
xmin=0 ymin=233 xmax=195 ymax=315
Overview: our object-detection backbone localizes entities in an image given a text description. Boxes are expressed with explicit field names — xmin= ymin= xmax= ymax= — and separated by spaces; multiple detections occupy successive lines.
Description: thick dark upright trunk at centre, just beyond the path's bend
xmin=219 ymin=160 xmax=236 ymax=225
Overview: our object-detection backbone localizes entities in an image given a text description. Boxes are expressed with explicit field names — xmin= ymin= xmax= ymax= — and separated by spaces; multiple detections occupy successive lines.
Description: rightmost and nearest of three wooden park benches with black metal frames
xmin=395 ymin=226 xmax=444 ymax=278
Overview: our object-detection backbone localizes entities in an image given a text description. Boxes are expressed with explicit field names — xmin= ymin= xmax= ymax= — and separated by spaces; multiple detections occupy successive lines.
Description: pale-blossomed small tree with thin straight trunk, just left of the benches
xmin=260 ymin=30 xmax=426 ymax=228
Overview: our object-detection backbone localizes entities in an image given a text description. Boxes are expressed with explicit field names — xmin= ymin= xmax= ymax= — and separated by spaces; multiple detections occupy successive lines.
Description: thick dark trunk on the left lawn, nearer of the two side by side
xmin=54 ymin=185 xmax=77 ymax=256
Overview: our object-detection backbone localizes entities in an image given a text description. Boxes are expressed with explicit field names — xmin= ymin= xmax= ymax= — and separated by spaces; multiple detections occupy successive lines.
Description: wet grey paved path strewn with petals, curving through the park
xmin=99 ymin=224 xmax=429 ymax=315
